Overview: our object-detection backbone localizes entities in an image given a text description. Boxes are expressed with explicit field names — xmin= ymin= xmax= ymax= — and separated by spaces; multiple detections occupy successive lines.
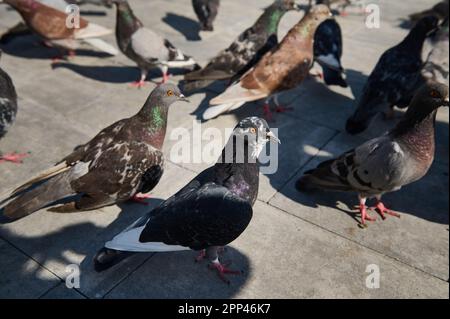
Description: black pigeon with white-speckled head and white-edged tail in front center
xmin=94 ymin=117 xmax=280 ymax=283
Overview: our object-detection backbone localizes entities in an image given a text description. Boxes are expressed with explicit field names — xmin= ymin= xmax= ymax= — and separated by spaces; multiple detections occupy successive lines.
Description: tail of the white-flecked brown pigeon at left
xmin=3 ymin=172 xmax=75 ymax=220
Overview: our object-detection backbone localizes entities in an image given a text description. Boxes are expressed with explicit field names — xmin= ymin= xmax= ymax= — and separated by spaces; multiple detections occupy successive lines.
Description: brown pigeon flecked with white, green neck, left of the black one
xmin=3 ymin=84 xmax=187 ymax=220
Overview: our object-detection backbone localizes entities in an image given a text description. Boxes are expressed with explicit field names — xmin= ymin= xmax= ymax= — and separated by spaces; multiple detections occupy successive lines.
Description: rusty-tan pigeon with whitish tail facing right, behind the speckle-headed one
xmin=203 ymin=5 xmax=331 ymax=120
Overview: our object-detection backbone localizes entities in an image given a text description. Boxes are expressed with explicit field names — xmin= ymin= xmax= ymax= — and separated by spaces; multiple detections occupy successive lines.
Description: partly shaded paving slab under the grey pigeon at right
xmin=269 ymin=134 xmax=449 ymax=280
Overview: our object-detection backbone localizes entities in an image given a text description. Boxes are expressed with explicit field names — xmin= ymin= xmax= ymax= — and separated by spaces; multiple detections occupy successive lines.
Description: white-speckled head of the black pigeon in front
xmin=231 ymin=117 xmax=281 ymax=159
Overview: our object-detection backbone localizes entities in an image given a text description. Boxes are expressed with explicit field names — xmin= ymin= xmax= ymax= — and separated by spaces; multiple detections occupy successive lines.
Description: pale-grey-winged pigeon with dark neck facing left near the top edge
xmin=111 ymin=0 xmax=197 ymax=88
